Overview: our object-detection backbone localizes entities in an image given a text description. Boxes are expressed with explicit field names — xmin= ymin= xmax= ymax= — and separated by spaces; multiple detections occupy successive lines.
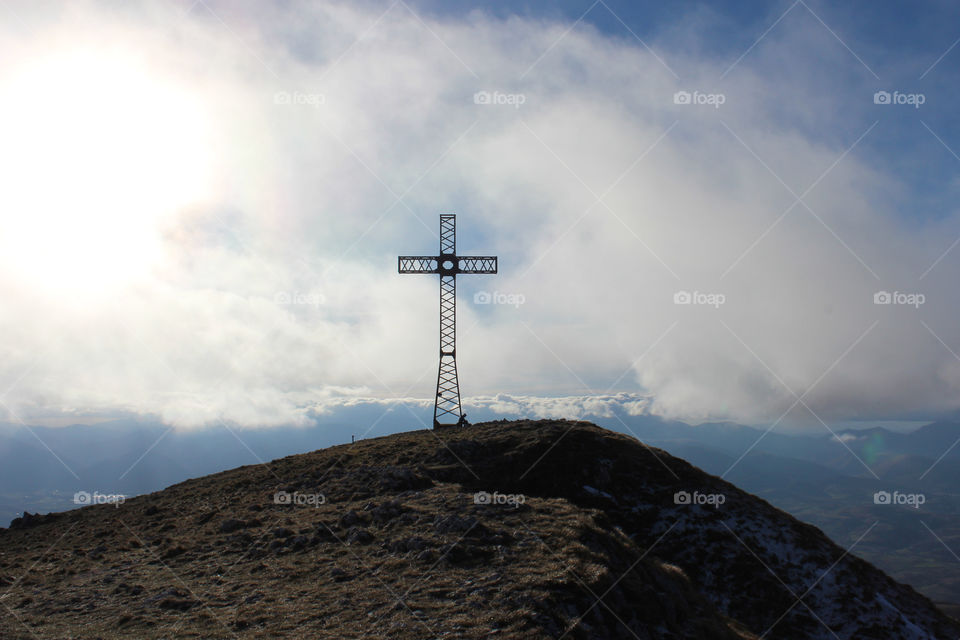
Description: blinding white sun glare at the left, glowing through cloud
xmin=0 ymin=52 xmax=211 ymax=295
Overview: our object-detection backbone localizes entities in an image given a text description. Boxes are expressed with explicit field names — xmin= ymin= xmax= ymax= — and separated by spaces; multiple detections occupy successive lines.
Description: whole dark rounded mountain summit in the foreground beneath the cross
xmin=0 ymin=421 xmax=960 ymax=640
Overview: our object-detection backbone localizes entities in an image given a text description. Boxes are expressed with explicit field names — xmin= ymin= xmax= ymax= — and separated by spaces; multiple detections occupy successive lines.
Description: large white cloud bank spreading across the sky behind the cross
xmin=0 ymin=3 xmax=960 ymax=428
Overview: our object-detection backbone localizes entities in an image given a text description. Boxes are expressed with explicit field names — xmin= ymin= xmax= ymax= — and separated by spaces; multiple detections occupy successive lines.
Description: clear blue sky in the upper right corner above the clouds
xmin=411 ymin=0 xmax=960 ymax=224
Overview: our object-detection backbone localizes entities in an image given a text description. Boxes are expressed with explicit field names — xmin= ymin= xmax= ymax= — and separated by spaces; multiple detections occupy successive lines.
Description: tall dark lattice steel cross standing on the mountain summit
xmin=397 ymin=213 xmax=497 ymax=429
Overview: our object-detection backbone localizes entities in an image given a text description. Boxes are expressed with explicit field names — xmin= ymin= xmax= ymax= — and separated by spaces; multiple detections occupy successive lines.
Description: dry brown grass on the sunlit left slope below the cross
xmin=0 ymin=422 xmax=744 ymax=639
